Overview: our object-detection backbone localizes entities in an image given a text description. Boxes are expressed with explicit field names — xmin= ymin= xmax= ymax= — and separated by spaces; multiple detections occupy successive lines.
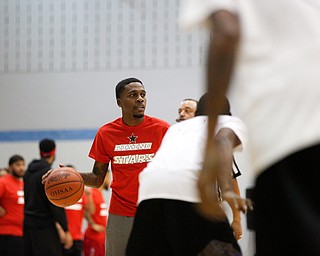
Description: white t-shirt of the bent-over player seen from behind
xmin=138 ymin=115 xmax=247 ymax=203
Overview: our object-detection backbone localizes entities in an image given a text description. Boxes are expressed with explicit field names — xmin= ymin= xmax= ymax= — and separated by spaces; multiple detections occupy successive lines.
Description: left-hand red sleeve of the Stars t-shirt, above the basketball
xmin=89 ymin=130 xmax=110 ymax=163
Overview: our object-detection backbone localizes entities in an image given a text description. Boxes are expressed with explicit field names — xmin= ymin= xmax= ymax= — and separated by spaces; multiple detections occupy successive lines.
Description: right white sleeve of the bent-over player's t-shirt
xmin=217 ymin=115 xmax=248 ymax=151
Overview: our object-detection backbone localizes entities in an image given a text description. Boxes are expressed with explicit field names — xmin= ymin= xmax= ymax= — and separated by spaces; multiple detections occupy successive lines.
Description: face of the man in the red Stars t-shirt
xmin=117 ymin=82 xmax=147 ymax=119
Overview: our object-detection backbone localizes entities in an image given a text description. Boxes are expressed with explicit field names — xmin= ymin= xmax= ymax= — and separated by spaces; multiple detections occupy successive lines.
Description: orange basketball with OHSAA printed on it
xmin=44 ymin=167 xmax=84 ymax=207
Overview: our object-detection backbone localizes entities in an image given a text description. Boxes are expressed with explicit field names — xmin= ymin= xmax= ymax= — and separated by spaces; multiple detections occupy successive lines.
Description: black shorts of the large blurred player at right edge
xmin=253 ymin=145 xmax=320 ymax=256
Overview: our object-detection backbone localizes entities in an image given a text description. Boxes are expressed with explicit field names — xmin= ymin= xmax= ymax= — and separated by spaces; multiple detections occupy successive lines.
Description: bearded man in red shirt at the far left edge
xmin=0 ymin=155 xmax=25 ymax=256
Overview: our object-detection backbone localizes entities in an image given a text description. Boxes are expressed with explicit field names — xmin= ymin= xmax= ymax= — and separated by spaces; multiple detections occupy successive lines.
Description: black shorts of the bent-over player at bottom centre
xmin=126 ymin=199 xmax=241 ymax=256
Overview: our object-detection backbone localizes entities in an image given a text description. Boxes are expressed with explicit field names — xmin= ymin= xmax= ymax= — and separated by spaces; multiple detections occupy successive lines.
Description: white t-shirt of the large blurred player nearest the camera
xmin=180 ymin=0 xmax=320 ymax=174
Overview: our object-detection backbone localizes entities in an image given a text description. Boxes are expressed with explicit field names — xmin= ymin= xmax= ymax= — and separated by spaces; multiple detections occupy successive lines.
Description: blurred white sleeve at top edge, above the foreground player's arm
xmin=179 ymin=0 xmax=239 ymax=29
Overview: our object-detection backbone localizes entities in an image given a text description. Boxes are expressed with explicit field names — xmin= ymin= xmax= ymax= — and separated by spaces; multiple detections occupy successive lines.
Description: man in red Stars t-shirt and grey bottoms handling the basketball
xmin=81 ymin=78 xmax=169 ymax=256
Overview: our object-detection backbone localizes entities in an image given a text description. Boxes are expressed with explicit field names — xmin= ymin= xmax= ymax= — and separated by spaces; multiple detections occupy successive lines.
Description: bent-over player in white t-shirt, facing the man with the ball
xmin=127 ymin=95 xmax=247 ymax=256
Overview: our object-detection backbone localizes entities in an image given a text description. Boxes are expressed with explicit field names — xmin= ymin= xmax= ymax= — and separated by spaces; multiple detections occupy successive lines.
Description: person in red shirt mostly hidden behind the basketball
xmin=56 ymin=164 xmax=88 ymax=256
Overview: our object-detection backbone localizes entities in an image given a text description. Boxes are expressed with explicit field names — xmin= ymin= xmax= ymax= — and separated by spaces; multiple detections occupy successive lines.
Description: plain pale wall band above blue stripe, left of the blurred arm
xmin=0 ymin=67 xmax=204 ymax=130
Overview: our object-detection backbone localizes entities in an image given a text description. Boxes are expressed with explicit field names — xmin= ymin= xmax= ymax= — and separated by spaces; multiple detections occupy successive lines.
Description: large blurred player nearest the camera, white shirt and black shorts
xmin=181 ymin=0 xmax=320 ymax=256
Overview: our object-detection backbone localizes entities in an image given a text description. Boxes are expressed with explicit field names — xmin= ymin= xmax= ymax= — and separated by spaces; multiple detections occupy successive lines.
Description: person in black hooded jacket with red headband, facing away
xmin=23 ymin=139 xmax=72 ymax=256
